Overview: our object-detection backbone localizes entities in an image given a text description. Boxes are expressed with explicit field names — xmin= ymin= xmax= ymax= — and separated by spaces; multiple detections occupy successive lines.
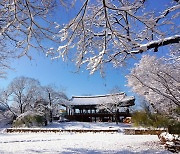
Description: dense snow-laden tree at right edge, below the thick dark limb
xmin=127 ymin=55 xmax=180 ymax=113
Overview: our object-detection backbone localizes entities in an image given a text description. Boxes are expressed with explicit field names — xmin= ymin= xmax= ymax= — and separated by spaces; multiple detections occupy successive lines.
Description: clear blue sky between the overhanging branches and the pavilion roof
xmin=0 ymin=0 xmax=171 ymax=101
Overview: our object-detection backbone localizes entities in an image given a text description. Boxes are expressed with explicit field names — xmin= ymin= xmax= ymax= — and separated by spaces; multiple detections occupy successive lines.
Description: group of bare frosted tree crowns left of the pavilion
xmin=0 ymin=77 xmax=68 ymax=118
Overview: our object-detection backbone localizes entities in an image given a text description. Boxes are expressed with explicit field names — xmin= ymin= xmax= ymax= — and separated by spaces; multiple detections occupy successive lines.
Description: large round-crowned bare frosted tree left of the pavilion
xmin=7 ymin=77 xmax=40 ymax=115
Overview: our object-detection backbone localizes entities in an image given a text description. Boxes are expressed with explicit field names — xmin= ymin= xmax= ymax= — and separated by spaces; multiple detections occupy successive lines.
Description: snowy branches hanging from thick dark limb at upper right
xmin=47 ymin=0 xmax=180 ymax=73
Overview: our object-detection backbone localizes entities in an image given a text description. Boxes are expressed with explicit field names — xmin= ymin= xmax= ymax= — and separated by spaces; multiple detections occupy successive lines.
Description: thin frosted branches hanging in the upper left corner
xmin=0 ymin=0 xmax=62 ymax=77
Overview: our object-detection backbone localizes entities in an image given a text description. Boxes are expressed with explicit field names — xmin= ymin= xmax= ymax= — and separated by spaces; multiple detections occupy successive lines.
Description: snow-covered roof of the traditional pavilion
xmin=70 ymin=92 xmax=135 ymax=106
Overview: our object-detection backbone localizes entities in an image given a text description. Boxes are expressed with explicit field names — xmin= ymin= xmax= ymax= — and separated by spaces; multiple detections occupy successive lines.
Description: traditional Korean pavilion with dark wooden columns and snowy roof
xmin=66 ymin=92 xmax=135 ymax=122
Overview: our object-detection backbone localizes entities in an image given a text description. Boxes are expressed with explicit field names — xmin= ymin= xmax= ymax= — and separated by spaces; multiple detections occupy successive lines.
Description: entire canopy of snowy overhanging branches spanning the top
xmin=0 ymin=0 xmax=180 ymax=77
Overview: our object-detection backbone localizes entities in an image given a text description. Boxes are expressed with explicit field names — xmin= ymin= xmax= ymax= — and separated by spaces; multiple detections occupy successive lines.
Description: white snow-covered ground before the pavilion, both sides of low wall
xmin=0 ymin=122 xmax=170 ymax=154
